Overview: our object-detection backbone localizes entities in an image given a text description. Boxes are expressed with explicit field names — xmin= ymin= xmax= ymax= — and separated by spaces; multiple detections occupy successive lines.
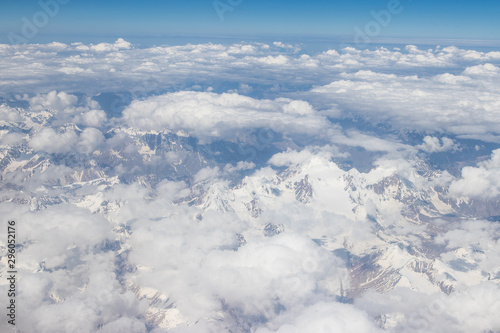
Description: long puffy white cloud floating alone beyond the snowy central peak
xmin=123 ymin=91 xmax=327 ymax=139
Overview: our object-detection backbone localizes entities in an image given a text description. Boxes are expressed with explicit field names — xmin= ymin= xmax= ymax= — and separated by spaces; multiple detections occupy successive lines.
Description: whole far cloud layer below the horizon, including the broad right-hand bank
xmin=0 ymin=39 xmax=500 ymax=142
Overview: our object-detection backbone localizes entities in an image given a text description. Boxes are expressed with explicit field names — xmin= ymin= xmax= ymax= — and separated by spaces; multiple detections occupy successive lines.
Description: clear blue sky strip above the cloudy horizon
xmin=0 ymin=0 xmax=500 ymax=43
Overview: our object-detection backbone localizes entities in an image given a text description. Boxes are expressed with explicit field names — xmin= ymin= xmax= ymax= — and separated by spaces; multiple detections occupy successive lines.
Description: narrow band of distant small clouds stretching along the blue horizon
xmin=0 ymin=39 xmax=500 ymax=100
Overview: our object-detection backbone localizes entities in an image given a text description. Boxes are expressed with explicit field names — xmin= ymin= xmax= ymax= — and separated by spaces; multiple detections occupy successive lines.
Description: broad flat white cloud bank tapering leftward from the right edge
xmin=312 ymin=66 xmax=500 ymax=142
